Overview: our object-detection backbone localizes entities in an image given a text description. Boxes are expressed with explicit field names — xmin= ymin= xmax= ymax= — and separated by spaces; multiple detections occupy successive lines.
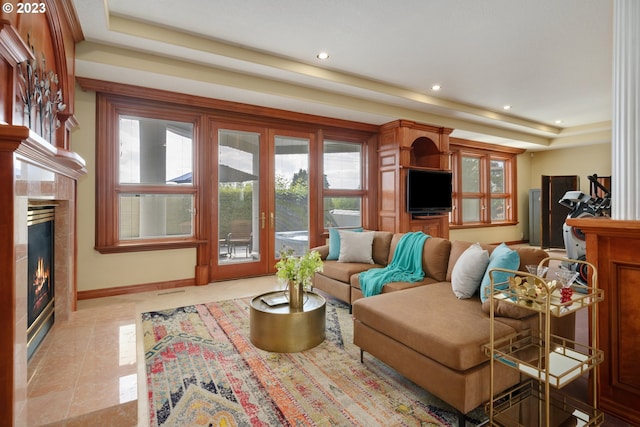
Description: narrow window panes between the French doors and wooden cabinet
xmin=323 ymin=140 xmax=364 ymax=228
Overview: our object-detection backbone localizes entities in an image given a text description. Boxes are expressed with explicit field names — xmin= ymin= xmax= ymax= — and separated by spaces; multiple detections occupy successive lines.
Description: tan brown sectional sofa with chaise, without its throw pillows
xmin=314 ymin=231 xmax=575 ymax=425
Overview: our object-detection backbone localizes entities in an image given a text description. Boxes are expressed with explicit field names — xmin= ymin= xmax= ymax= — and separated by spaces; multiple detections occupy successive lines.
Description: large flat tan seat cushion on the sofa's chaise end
xmin=353 ymin=282 xmax=515 ymax=371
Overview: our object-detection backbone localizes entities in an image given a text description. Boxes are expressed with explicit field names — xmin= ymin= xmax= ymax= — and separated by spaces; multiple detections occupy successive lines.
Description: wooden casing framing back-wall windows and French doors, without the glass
xmin=90 ymin=78 xmax=378 ymax=254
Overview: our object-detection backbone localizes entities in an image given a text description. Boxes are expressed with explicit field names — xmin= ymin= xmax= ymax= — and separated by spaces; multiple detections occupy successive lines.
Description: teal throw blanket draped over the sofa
xmin=360 ymin=231 xmax=431 ymax=297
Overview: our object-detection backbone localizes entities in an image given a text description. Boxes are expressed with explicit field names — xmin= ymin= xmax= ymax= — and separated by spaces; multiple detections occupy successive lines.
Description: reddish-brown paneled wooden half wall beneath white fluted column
xmin=567 ymin=217 xmax=640 ymax=425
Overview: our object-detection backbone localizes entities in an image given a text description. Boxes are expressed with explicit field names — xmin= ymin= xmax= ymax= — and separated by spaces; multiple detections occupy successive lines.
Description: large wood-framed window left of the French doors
xmin=96 ymin=95 xmax=197 ymax=252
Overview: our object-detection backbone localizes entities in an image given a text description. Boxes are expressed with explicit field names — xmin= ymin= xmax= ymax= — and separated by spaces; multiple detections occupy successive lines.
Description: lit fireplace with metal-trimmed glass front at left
xmin=27 ymin=205 xmax=55 ymax=359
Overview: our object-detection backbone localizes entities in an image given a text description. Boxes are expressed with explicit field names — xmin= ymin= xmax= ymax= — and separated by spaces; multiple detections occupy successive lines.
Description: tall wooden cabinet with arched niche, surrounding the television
xmin=378 ymin=120 xmax=453 ymax=238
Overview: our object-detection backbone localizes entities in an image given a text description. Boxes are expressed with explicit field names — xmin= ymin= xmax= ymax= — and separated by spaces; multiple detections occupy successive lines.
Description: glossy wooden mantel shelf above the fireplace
xmin=0 ymin=125 xmax=87 ymax=179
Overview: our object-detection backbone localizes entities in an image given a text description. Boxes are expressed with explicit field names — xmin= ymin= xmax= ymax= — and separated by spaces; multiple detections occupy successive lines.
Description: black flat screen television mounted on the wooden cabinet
xmin=407 ymin=169 xmax=452 ymax=215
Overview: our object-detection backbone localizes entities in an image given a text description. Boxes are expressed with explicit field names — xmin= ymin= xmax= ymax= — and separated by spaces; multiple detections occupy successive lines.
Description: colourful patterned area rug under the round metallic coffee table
xmin=142 ymin=299 xmax=484 ymax=427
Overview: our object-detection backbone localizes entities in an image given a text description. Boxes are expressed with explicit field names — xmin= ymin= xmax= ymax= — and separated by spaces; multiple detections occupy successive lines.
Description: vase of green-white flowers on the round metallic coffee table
xmin=276 ymin=249 xmax=322 ymax=310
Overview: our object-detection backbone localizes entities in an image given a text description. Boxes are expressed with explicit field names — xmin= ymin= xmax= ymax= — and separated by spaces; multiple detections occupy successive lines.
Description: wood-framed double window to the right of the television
xmin=450 ymin=138 xmax=523 ymax=227
